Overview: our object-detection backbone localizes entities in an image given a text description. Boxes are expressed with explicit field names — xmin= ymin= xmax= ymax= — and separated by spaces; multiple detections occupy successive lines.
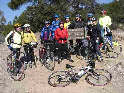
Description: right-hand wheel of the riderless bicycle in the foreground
xmin=85 ymin=69 xmax=112 ymax=86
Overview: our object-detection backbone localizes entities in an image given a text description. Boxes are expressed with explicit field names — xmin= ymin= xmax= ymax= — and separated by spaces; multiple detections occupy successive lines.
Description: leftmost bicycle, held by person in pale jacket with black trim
xmin=7 ymin=50 xmax=25 ymax=81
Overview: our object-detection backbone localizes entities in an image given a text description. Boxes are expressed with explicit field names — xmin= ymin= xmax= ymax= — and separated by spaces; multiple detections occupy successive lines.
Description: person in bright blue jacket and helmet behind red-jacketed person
xmin=52 ymin=14 xmax=60 ymax=35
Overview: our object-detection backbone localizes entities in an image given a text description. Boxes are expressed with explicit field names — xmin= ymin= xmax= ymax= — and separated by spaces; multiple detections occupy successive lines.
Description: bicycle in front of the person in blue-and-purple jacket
xmin=39 ymin=40 xmax=55 ymax=71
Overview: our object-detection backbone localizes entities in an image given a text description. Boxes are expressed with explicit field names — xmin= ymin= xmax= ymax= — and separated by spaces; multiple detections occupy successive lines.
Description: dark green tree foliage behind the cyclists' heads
xmin=9 ymin=0 xmax=124 ymax=32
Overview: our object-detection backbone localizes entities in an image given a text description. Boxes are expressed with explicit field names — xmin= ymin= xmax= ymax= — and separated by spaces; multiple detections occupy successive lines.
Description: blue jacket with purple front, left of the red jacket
xmin=41 ymin=26 xmax=54 ymax=40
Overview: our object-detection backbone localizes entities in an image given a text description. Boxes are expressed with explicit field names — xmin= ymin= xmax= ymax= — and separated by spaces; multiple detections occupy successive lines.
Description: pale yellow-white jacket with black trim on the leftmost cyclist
xmin=5 ymin=30 xmax=22 ymax=48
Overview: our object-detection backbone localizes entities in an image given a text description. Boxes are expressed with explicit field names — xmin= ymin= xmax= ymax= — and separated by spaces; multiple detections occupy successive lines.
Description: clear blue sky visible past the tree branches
xmin=0 ymin=0 xmax=113 ymax=23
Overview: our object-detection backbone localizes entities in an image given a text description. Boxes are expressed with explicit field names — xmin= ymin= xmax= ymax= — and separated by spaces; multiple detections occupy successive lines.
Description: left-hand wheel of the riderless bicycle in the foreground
xmin=48 ymin=71 xmax=71 ymax=87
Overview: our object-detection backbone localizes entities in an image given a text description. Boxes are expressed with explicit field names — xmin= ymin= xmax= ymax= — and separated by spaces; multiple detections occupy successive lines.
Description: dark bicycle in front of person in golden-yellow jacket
xmin=22 ymin=42 xmax=38 ymax=70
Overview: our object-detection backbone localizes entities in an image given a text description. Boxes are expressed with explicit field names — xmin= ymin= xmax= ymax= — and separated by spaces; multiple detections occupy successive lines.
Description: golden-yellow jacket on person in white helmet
xmin=21 ymin=31 xmax=37 ymax=44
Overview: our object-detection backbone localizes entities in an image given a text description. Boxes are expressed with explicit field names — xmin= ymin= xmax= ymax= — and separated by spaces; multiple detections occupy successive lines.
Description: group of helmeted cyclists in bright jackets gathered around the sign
xmin=5 ymin=10 xmax=113 ymax=67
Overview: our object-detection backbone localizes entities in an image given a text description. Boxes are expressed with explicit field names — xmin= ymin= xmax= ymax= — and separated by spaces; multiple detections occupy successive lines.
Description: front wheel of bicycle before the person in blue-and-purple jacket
xmin=43 ymin=52 xmax=55 ymax=71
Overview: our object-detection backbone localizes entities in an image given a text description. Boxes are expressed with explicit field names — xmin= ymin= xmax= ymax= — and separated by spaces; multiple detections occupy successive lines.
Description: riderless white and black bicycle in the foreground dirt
xmin=48 ymin=64 xmax=112 ymax=87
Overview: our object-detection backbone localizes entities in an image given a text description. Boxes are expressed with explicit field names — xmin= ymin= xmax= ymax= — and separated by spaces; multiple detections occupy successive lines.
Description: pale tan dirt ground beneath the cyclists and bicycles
xmin=0 ymin=32 xmax=124 ymax=93
